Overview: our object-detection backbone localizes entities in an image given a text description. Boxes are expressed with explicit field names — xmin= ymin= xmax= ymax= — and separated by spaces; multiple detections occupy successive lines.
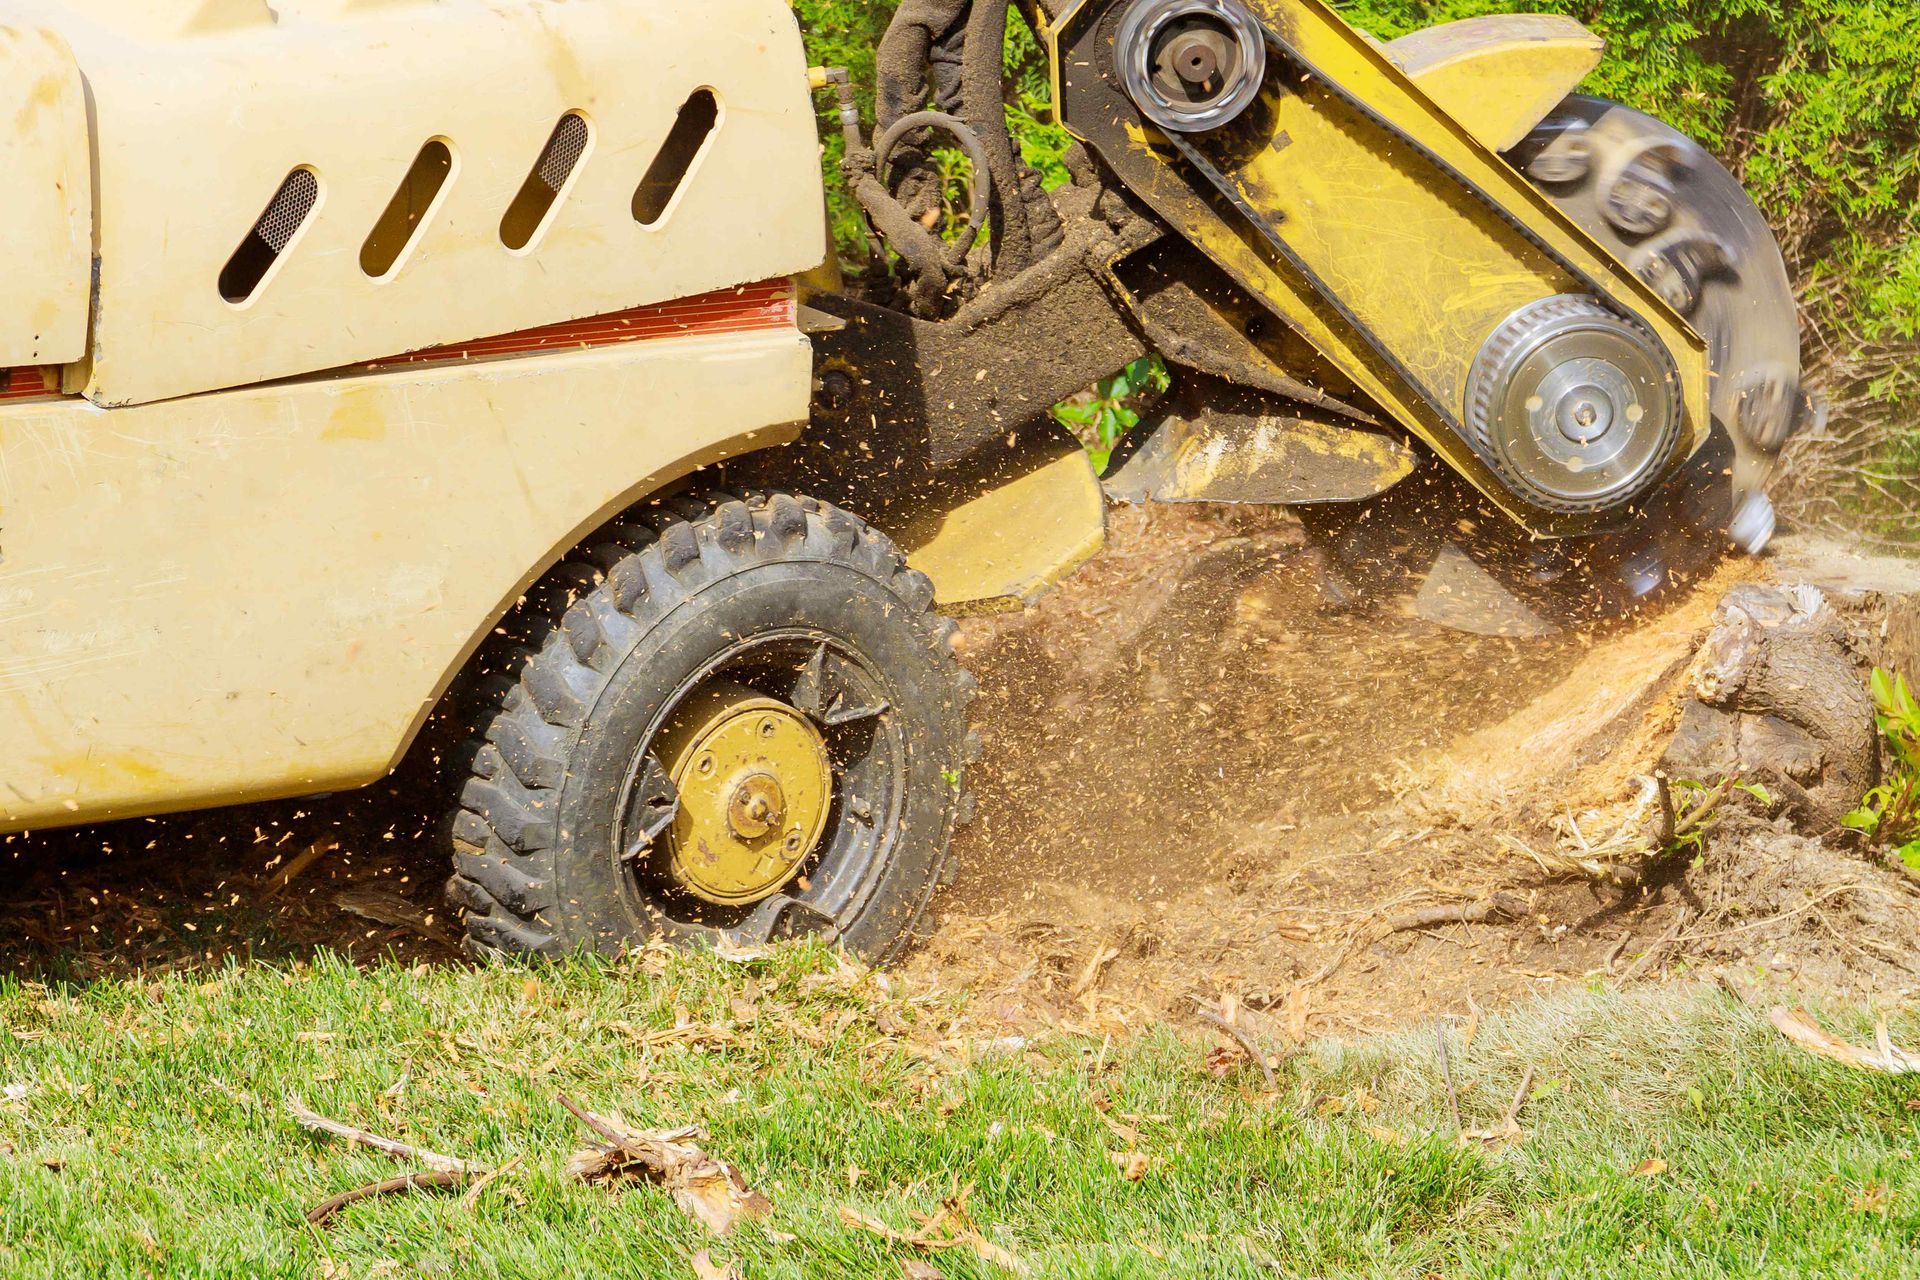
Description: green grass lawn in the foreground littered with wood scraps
xmin=0 ymin=950 xmax=1920 ymax=1280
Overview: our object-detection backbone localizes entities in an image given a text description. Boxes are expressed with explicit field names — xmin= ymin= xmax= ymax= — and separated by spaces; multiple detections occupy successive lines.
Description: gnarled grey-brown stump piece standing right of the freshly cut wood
xmin=1661 ymin=585 xmax=1880 ymax=835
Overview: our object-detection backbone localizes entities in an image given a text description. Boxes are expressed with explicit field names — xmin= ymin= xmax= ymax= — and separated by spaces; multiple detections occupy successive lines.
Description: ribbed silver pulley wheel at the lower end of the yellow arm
xmin=1465 ymin=294 xmax=1682 ymax=512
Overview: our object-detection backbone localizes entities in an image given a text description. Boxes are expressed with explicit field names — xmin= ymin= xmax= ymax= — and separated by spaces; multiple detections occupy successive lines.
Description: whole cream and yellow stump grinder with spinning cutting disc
xmin=0 ymin=0 xmax=1820 ymax=960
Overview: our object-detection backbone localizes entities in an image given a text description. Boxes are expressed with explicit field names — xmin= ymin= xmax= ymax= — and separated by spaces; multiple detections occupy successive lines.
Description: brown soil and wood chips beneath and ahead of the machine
xmin=0 ymin=509 xmax=1920 ymax=1036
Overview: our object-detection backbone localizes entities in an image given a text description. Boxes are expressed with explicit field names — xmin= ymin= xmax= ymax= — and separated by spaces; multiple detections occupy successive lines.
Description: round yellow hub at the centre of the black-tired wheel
xmin=657 ymin=681 xmax=833 ymax=906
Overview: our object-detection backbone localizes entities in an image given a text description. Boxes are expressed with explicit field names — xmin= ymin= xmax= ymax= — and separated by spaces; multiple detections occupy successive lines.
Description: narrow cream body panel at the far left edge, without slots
xmin=0 ymin=20 xmax=94 ymax=367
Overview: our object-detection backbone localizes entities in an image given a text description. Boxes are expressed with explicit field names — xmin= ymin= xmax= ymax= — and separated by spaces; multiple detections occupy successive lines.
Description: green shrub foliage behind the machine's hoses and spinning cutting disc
xmin=795 ymin=0 xmax=1920 ymax=535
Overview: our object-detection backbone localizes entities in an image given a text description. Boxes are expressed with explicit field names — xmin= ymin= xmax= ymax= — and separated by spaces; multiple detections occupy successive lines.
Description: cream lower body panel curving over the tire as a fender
xmin=0 ymin=330 xmax=812 ymax=831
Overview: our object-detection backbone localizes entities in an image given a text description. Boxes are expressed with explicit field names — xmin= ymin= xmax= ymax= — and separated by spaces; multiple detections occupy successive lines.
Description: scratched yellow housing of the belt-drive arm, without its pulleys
xmin=1048 ymin=0 xmax=1713 ymax=532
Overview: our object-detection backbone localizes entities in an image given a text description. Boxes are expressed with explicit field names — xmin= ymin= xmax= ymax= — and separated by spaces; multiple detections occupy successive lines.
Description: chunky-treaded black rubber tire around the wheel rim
xmin=447 ymin=493 xmax=977 ymax=963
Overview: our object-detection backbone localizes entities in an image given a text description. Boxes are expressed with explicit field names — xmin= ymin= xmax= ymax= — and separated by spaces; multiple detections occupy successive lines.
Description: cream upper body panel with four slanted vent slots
xmin=44 ymin=0 xmax=826 ymax=405
